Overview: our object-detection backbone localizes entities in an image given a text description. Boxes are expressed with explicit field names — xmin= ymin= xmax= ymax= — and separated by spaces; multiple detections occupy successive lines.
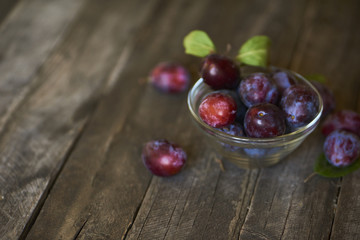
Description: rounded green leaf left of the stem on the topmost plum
xmin=183 ymin=30 xmax=216 ymax=57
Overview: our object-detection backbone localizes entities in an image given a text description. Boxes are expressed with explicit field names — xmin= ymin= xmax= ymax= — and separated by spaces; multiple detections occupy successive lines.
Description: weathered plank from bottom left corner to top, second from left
xmin=0 ymin=0 xmax=160 ymax=239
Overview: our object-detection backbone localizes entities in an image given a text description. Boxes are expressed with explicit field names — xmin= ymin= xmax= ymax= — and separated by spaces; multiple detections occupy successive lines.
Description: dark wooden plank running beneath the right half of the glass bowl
xmin=240 ymin=1 xmax=359 ymax=239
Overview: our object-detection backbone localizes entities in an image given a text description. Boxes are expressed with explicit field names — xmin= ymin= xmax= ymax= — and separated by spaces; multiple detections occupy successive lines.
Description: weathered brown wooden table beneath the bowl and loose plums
xmin=0 ymin=0 xmax=360 ymax=240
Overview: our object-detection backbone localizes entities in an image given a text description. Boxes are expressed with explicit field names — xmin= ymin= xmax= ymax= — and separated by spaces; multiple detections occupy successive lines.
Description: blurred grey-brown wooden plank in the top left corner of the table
xmin=0 ymin=0 xmax=84 ymax=135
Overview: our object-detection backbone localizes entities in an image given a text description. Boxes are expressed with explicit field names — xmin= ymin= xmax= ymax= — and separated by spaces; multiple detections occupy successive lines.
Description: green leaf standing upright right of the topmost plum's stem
xmin=236 ymin=36 xmax=271 ymax=67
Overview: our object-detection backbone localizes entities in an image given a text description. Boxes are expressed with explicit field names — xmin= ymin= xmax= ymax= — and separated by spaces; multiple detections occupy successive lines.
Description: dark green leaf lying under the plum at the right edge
xmin=314 ymin=153 xmax=360 ymax=178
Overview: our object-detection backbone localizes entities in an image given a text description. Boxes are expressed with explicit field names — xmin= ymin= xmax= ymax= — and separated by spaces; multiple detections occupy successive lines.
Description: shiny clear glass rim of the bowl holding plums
xmin=187 ymin=67 xmax=324 ymax=145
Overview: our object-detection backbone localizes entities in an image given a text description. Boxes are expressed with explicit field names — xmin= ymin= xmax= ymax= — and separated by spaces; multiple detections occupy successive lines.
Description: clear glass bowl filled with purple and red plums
xmin=187 ymin=68 xmax=323 ymax=168
